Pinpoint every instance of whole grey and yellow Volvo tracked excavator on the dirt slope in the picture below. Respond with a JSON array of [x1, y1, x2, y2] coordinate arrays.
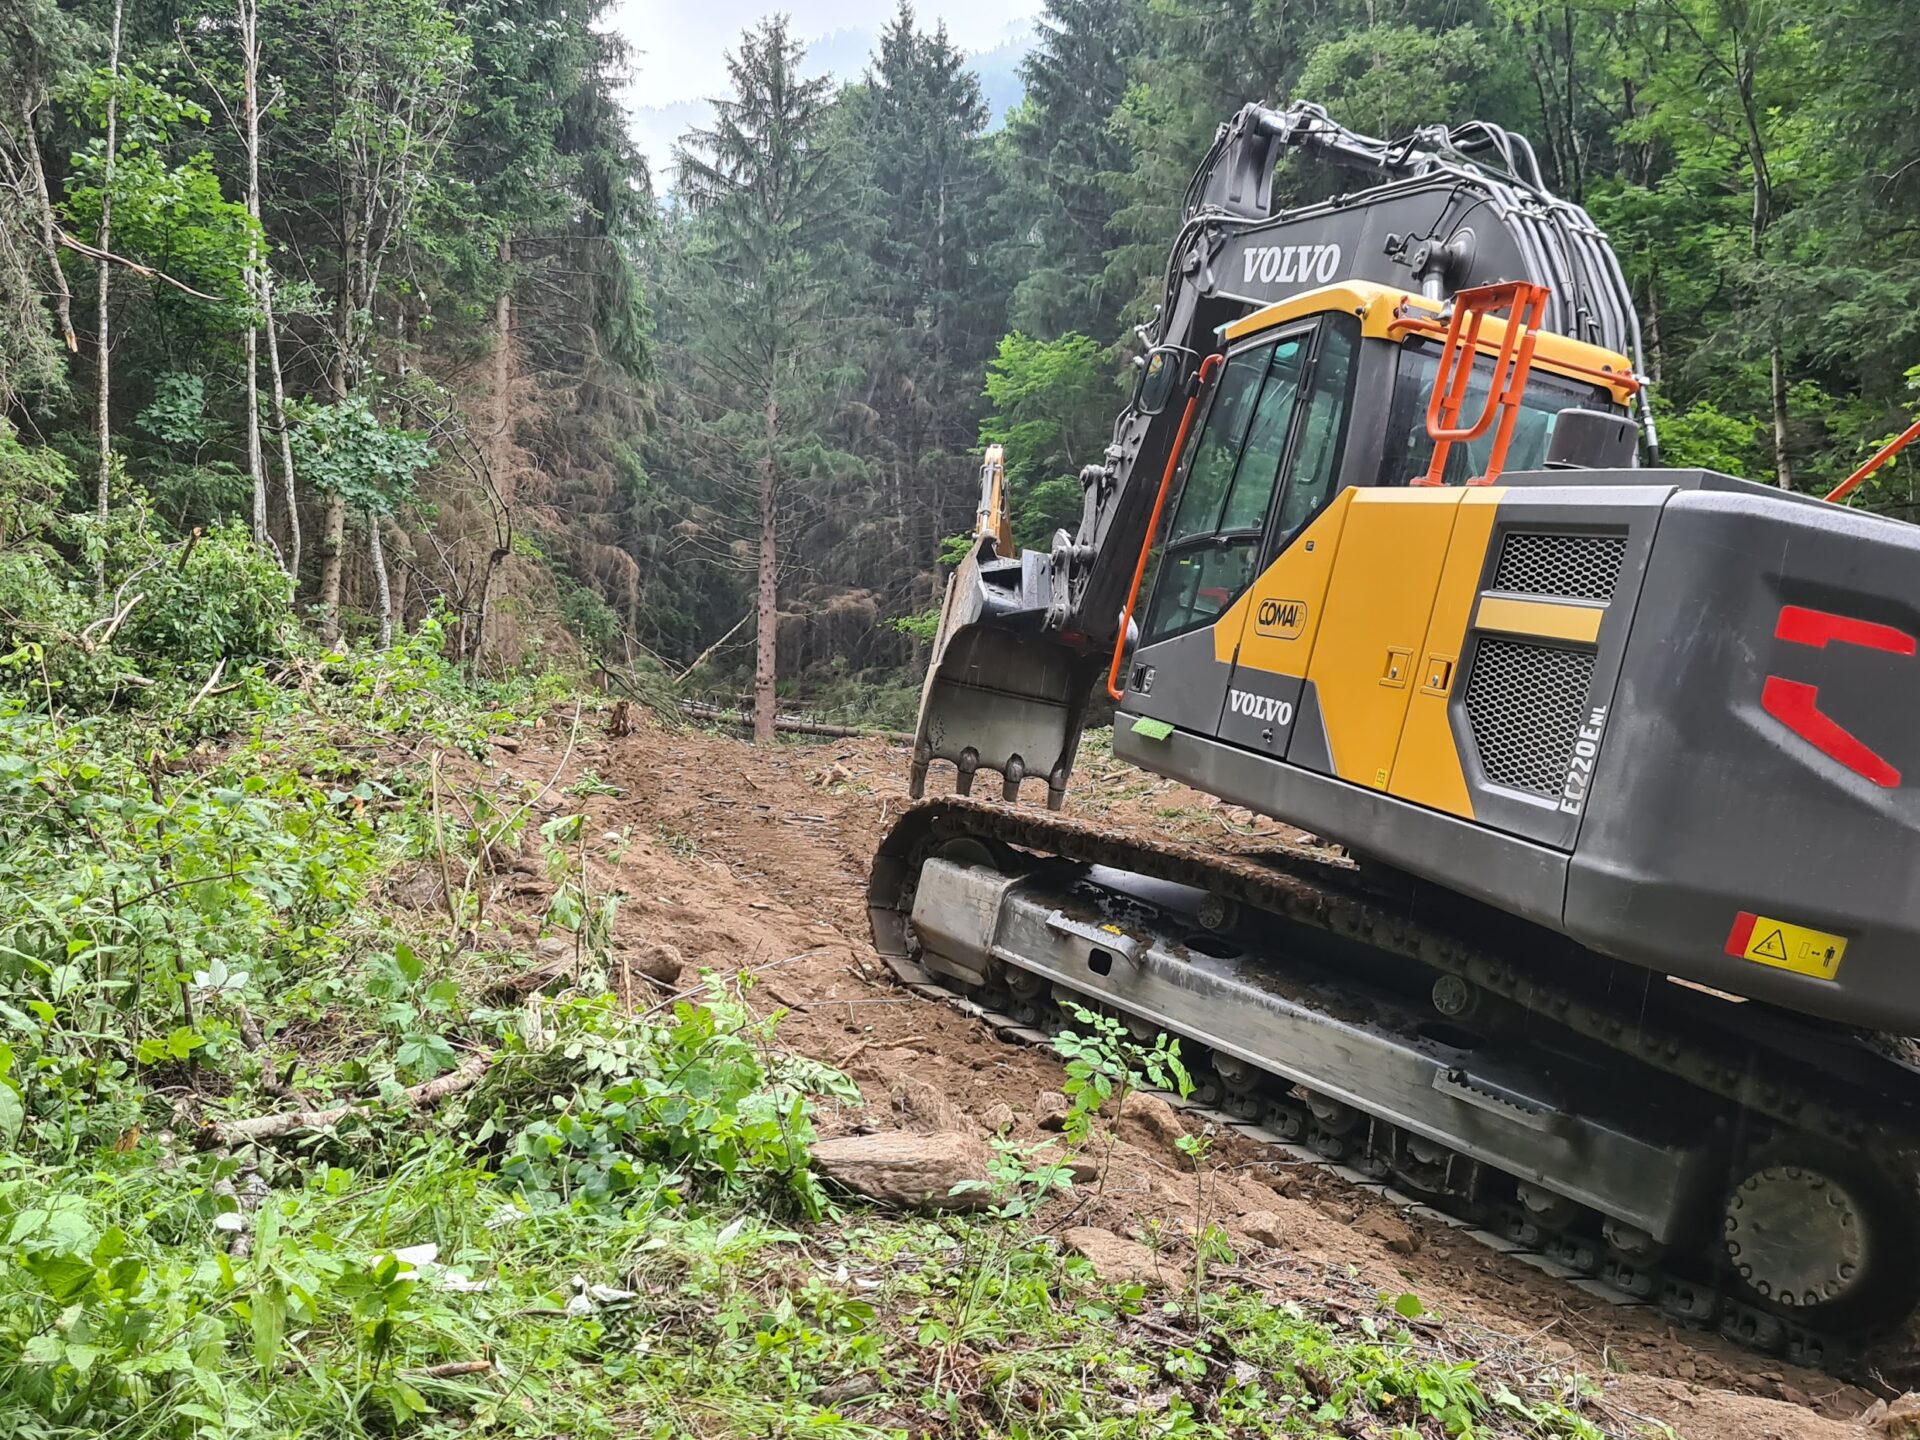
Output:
[[870, 102, 1920, 1365]]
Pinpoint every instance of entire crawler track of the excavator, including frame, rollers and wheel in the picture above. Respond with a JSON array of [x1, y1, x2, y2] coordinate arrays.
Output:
[[868, 797, 1920, 1371]]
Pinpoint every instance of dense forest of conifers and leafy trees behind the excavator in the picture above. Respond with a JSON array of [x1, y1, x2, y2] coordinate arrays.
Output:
[[0, 0, 1920, 708]]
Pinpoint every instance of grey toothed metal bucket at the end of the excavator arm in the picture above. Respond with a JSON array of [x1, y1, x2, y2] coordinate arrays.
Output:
[[908, 445, 1098, 810]]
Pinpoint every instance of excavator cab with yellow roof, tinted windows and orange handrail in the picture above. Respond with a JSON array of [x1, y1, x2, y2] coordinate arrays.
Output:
[[1112, 282, 1634, 749]]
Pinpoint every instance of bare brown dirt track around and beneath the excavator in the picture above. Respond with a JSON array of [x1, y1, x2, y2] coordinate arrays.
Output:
[[465, 710, 1874, 1440]]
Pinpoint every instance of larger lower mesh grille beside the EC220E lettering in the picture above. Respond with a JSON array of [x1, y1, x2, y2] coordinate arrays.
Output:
[[1467, 639, 1594, 795]]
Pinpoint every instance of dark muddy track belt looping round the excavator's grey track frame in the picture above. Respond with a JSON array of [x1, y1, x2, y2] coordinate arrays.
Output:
[[868, 799, 1920, 1371]]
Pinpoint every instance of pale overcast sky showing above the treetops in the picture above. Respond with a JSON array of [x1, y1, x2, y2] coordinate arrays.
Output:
[[611, 0, 1041, 184]]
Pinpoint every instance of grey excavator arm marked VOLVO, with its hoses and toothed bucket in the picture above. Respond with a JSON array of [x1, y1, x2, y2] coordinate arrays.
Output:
[[912, 102, 1657, 808]]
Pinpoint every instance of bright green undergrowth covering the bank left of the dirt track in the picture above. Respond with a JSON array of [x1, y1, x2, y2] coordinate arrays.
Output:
[[0, 488, 1620, 1440]]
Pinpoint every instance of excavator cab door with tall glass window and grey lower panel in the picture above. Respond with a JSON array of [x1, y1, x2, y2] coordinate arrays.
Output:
[[1125, 321, 1319, 735]]
